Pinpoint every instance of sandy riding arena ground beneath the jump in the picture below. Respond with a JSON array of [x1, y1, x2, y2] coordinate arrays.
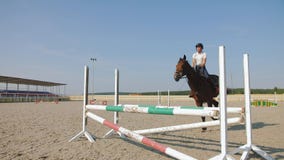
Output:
[[0, 95, 284, 160]]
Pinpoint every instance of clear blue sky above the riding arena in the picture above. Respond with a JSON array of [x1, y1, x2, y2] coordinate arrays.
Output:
[[0, 0, 284, 94]]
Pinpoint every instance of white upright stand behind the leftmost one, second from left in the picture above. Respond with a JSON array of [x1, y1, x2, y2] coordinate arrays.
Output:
[[104, 68, 121, 138]]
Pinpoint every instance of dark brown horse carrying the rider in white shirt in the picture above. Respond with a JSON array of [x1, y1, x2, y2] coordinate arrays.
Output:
[[174, 55, 219, 131]]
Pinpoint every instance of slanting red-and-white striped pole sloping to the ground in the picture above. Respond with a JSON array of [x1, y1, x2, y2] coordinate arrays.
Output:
[[87, 112, 196, 160]]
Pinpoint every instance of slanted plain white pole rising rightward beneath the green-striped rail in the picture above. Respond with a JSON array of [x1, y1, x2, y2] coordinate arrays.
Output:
[[133, 117, 244, 134]]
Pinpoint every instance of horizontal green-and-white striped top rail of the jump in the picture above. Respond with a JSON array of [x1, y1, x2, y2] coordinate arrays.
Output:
[[86, 105, 219, 117]]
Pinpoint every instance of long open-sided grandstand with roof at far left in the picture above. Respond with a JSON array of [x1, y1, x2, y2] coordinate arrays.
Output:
[[0, 76, 66, 102]]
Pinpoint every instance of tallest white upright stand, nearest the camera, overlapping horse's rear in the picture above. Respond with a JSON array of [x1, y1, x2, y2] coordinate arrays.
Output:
[[211, 46, 234, 160]]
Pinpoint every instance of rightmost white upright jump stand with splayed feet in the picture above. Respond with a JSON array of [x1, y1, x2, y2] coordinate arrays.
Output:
[[231, 54, 274, 160]]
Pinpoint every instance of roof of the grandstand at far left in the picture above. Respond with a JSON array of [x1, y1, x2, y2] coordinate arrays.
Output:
[[0, 76, 66, 87]]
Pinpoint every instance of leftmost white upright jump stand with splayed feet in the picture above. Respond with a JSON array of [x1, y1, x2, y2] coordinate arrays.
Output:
[[69, 66, 95, 142]]
